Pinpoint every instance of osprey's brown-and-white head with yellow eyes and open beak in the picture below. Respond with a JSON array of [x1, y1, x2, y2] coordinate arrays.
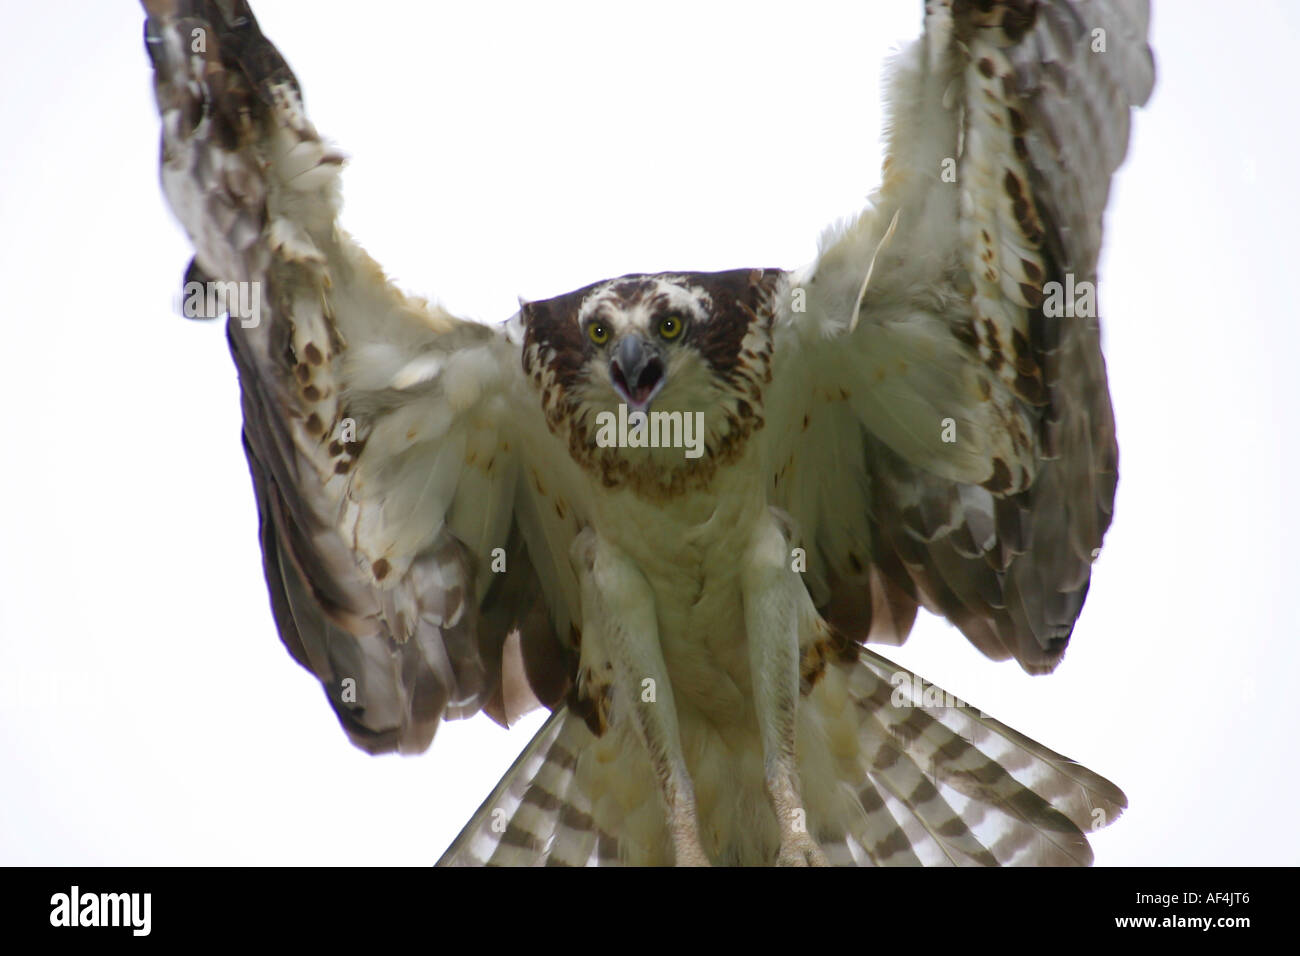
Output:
[[521, 269, 781, 494]]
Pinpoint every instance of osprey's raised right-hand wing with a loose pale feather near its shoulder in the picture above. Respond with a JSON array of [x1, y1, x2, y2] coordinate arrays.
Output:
[[764, 0, 1154, 672]]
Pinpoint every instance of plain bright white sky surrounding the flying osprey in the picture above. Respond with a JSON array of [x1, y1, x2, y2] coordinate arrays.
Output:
[[0, 0, 1300, 865]]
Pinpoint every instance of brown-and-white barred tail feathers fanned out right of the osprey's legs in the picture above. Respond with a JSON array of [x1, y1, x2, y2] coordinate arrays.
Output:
[[827, 650, 1127, 866]]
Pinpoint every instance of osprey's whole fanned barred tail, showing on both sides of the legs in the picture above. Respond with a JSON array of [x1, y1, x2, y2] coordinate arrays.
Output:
[[438, 649, 1127, 866]]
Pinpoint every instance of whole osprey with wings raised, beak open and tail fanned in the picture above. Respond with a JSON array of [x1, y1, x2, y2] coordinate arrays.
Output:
[[144, 0, 1154, 865]]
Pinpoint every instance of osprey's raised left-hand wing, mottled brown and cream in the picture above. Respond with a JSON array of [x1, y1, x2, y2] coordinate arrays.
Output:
[[144, 0, 582, 752]]
